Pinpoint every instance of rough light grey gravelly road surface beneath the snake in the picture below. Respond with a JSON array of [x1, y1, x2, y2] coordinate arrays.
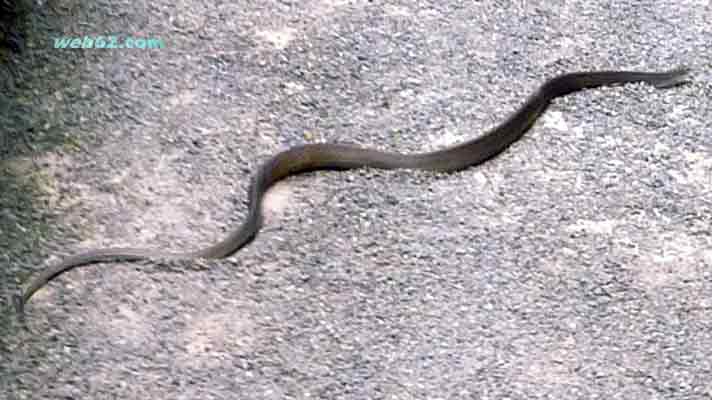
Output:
[[0, 0, 712, 400]]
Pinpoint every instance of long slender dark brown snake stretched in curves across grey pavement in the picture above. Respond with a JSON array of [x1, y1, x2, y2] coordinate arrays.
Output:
[[13, 67, 690, 314]]
